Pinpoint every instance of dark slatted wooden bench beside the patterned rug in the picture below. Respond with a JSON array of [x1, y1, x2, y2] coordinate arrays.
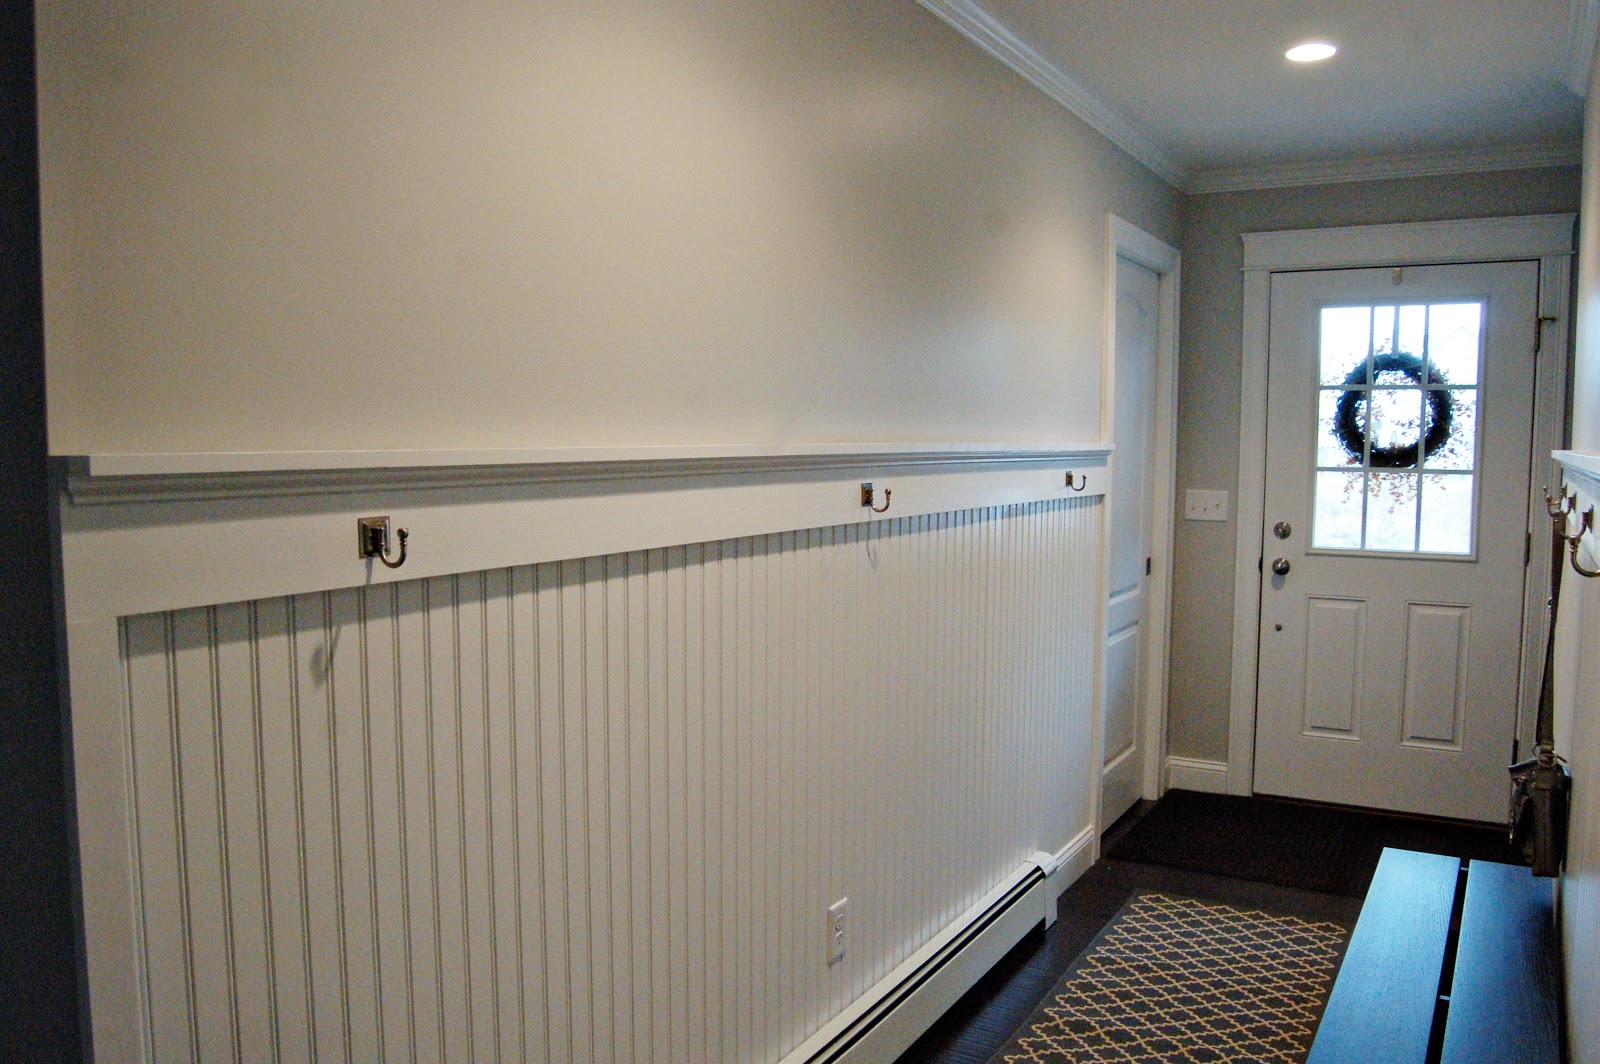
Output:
[[1307, 850, 1562, 1064]]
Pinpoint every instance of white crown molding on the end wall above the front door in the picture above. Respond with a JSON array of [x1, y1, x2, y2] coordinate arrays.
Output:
[[1186, 139, 1580, 194]]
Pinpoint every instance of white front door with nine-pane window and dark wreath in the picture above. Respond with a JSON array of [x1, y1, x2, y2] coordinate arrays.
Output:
[[1254, 262, 1539, 821]]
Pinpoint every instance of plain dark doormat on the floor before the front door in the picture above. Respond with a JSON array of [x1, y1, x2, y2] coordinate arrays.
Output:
[[1106, 790, 1517, 898]]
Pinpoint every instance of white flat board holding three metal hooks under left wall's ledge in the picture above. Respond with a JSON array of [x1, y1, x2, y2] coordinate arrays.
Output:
[[61, 448, 1109, 621]]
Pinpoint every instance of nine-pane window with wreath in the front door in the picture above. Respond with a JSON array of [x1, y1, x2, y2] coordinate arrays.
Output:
[[1312, 302, 1483, 555]]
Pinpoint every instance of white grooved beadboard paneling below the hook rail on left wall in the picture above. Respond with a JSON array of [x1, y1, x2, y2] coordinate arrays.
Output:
[[106, 496, 1102, 1064]]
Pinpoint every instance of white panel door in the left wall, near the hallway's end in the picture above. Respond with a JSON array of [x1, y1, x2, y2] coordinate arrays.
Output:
[[1101, 258, 1160, 827]]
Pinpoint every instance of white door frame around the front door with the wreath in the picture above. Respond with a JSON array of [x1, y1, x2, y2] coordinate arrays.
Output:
[[1227, 214, 1576, 795]]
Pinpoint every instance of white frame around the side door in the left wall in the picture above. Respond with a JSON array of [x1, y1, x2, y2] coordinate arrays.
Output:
[[1093, 214, 1181, 812]]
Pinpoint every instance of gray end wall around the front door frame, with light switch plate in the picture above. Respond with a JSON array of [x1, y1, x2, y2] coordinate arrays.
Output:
[[1168, 166, 1579, 760]]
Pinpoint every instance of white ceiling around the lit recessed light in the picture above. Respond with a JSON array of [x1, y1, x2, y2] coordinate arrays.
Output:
[[923, 0, 1600, 189]]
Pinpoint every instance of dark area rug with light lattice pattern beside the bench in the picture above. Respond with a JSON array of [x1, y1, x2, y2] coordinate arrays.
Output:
[[992, 893, 1347, 1064]]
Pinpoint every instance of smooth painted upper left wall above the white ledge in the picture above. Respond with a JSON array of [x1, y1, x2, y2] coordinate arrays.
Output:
[[37, 0, 1181, 454]]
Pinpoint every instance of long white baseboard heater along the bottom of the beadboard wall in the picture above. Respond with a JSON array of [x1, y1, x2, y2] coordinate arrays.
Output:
[[782, 853, 1059, 1064]]
